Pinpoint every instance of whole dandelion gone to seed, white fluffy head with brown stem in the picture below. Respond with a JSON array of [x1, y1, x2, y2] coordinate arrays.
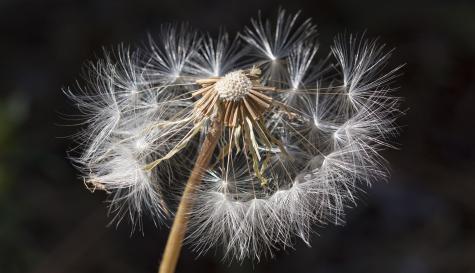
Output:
[[67, 10, 400, 272]]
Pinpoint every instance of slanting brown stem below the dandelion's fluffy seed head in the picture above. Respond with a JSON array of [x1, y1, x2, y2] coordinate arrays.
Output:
[[158, 112, 223, 273]]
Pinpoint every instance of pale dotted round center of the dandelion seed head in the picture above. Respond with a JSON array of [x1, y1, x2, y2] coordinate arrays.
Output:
[[214, 70, 252, 101]]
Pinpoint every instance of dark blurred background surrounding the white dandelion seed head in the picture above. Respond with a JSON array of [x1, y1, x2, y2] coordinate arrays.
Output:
[[0, 0, 475, 273]]
